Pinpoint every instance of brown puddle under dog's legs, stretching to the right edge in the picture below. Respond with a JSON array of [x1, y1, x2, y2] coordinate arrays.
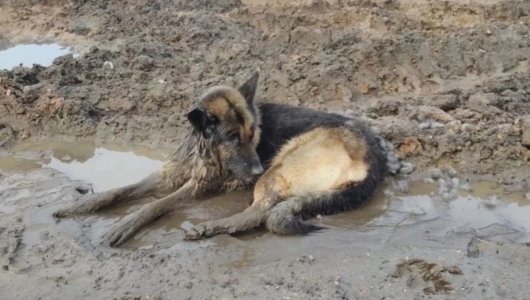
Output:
[[118, 178, 530, 267]]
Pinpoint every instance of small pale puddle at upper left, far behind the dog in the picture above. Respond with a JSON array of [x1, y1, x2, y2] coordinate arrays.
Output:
[[0, 43, 72, 69]]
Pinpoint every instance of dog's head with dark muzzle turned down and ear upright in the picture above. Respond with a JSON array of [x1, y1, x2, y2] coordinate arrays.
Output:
[[188, 72, 263, 180]]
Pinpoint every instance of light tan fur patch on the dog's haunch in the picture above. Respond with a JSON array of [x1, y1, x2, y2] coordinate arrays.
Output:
[[254, 128, 368, 202]]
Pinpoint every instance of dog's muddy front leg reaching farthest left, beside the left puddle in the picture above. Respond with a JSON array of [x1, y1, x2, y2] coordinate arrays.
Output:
[[53, 173, 160, 218]]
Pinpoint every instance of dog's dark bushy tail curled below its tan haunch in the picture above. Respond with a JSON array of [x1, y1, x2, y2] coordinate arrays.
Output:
[[266, 166, 382, 234]]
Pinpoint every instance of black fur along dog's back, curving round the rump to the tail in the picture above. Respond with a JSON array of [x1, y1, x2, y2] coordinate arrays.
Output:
[[257, 103, 387, 233]]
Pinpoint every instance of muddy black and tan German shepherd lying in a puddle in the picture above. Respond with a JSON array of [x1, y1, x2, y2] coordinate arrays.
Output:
[[54, 71, 387, 246]]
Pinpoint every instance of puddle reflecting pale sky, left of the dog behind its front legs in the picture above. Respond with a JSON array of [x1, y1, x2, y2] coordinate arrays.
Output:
[[0, 141, 164, 192]]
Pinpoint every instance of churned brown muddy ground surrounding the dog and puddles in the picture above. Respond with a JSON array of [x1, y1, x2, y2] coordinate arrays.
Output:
[[0, 0, 530, 299]]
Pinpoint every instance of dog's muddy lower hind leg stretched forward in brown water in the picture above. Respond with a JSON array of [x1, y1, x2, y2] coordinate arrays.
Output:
[[185, 203, 270, 240]]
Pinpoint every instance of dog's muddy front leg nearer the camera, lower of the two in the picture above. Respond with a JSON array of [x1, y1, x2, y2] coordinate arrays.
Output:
[[103, 179, 197, 247]]
